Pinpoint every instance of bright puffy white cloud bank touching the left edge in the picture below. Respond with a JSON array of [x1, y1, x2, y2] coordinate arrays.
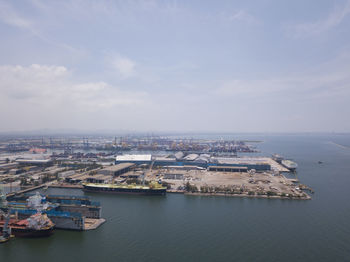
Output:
[[0, 64, 146, 112]]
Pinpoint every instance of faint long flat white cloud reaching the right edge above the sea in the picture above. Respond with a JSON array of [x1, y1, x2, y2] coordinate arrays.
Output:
[[215, 72, 350, 101]]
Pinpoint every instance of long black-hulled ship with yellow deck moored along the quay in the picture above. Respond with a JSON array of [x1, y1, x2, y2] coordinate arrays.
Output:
[[83, 183, 166, 195]]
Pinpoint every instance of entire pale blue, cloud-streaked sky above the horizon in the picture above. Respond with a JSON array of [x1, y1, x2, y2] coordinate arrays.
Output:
[[0, 0, 350, 132]]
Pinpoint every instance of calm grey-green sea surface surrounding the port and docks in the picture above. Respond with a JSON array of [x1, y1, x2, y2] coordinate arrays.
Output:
[[0, 135, 350, 262]]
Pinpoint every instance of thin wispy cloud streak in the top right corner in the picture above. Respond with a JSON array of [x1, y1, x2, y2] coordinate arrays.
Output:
[[287, 0, 350, 38]]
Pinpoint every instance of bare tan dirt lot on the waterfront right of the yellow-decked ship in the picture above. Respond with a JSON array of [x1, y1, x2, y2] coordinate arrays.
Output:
[[146, 169, 306, 197]]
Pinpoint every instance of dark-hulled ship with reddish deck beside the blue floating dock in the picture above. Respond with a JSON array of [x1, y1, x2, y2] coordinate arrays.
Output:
[[0, 213, 55, 237]]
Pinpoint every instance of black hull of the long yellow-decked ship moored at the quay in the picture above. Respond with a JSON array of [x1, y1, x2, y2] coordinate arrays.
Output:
[[83, 185, 166, 196]]
